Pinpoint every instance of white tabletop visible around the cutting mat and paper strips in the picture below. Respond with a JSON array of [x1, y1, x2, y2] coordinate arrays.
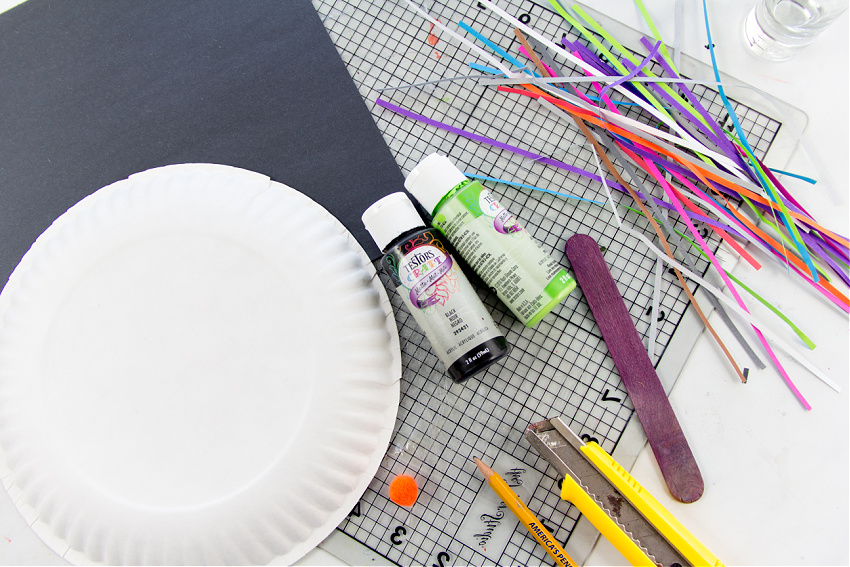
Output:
[[0, 0, 850, 565]]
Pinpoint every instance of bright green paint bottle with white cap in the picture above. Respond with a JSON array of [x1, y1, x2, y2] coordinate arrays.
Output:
[[404, 154, 576, 327]]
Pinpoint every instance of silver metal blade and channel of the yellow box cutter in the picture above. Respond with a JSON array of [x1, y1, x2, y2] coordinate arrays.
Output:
[[525, 418, 690, 567]]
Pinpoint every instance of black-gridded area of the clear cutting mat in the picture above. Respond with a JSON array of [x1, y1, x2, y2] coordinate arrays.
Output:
[[314, 0, 779, 567]]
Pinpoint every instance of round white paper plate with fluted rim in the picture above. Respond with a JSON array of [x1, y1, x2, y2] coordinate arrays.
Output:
[[0, 164, 401, 564]]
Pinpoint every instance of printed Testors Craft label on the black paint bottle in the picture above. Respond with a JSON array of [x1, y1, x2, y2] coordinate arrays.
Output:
[[382, 230, 507, 377]]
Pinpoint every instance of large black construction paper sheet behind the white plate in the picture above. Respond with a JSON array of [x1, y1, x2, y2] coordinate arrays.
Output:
[[0, 0, 404, 284]]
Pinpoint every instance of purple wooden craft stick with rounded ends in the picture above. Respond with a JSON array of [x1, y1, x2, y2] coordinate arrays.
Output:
[[566, 234, 704, 502]]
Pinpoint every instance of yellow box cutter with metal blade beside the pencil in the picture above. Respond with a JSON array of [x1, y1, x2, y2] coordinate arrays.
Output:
[[525, 417, 723, 567]]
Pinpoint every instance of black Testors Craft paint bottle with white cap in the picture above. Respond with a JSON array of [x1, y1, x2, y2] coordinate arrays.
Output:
[[362, 193, 510, 382]]
